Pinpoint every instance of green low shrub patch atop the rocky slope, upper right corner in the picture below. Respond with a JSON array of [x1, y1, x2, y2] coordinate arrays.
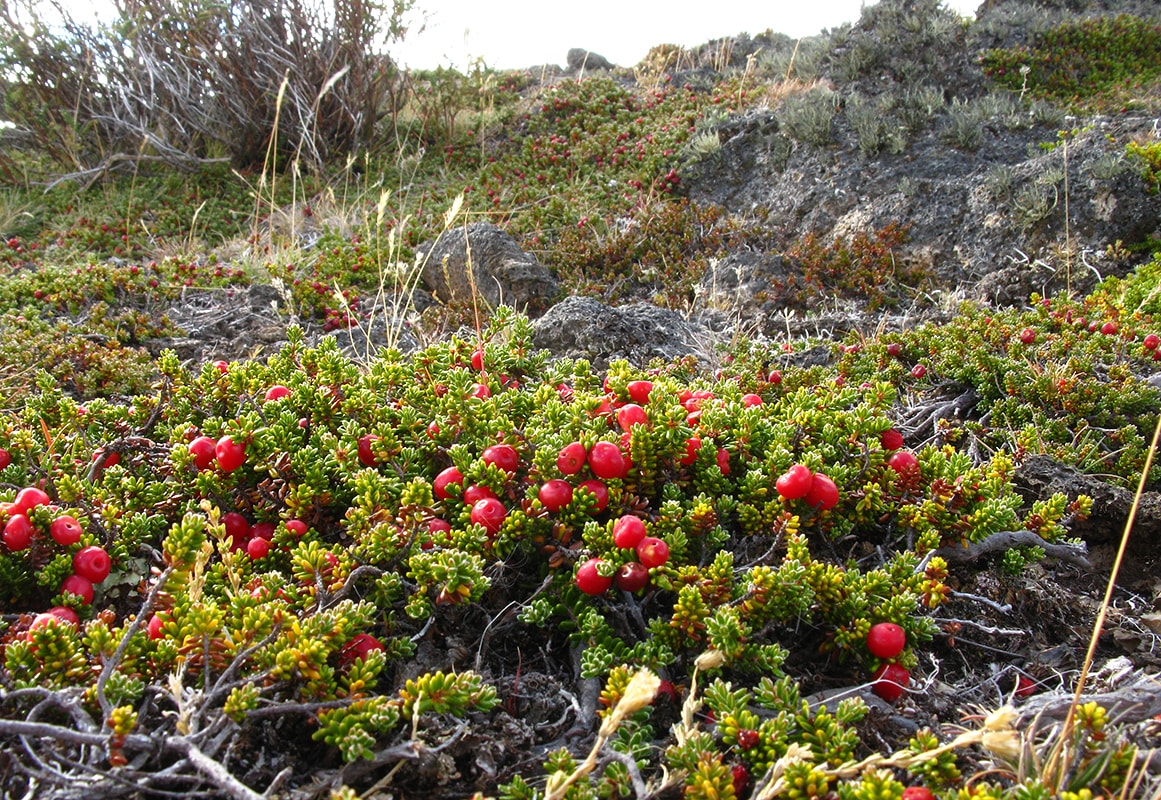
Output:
[[982, 14, 1161, 110]]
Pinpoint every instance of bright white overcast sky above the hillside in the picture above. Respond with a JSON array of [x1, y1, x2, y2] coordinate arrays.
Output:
[[49, 0, 982, 70]]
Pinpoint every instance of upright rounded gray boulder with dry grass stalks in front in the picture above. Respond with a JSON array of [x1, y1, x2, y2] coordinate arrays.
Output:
[[418, 222, 558, 316]]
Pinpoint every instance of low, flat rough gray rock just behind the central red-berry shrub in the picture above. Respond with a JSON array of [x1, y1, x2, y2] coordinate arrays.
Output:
[[533, 297, 712, 369]]
